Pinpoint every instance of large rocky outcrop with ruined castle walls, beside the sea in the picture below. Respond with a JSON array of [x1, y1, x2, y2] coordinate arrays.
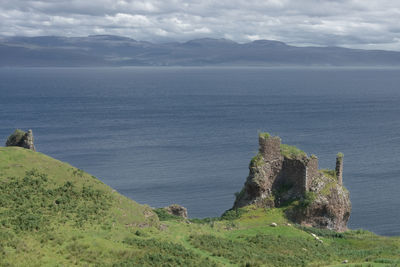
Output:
[[233, 134, 351, 231]]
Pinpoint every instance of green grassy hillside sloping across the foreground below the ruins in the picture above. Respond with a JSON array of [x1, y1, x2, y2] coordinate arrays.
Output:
[[0, 147, 400, 266]]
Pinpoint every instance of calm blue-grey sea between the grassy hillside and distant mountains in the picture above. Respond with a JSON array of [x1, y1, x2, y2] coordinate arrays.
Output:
[[0, 68, 400, 235]]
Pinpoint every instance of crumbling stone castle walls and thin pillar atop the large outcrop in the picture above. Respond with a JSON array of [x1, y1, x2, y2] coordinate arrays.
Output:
[[234, 134, 343, 208]]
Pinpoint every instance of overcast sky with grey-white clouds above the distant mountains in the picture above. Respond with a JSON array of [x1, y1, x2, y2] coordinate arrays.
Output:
[[0, 0, 400, 50]]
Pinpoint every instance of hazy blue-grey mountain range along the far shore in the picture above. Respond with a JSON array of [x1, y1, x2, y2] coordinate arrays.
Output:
[[0, 35, 400, 67]]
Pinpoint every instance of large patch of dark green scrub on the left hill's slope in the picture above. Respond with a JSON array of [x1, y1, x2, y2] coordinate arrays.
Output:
[[0, 169, 111, 231]]
